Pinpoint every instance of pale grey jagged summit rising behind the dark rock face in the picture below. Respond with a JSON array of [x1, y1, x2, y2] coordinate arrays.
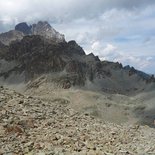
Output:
[[0, 21, 65, 45]]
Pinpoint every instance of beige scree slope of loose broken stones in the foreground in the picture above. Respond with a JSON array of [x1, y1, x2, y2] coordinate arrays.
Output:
[[0, 87, 155, 155]]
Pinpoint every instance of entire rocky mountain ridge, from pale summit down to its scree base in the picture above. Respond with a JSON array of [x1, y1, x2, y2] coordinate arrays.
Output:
[[0, 21, 155, 94]]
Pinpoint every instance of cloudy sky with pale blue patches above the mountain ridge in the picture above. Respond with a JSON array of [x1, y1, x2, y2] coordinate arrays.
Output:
[[0, 0, 155, 74]]
